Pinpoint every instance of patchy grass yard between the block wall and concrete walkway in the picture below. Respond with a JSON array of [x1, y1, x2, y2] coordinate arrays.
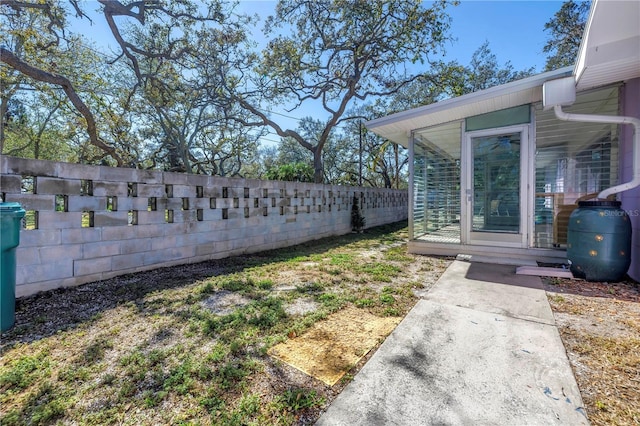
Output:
[[0, 223, 448, 425]]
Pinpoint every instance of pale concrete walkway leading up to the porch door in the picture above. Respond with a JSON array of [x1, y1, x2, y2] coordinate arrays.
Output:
[[316, 261, 589, 426]]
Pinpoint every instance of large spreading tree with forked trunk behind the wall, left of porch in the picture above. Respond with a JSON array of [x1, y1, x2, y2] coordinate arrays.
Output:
[[230, 0, 458, 182]]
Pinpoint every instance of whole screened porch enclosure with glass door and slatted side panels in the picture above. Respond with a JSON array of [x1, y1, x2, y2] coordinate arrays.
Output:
[[410, 86, 619, 250]]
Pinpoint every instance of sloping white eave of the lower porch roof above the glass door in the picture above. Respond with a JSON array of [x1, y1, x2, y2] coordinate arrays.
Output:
[[365, 67, 573, 147]]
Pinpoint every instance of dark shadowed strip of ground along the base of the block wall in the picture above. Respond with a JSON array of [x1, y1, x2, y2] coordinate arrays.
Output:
[[0, 221, 407, 355]]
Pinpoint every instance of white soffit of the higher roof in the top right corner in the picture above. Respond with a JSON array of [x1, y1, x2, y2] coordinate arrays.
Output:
[[574, 0, 640, 90]]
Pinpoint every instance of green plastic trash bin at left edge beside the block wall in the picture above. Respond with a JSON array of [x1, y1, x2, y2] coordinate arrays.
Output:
[[0, 203, 25, 331]]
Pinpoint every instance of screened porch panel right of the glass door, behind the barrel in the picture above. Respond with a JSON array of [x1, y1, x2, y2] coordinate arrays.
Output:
[[533, 86, 620, 248]]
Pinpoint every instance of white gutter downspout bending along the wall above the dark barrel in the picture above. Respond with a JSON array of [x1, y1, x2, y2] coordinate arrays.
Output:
[[553, 105, 640, 199]]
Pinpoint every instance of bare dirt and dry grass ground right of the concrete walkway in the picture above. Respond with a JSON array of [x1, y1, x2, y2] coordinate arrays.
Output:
[[543, 278, 640, 426]]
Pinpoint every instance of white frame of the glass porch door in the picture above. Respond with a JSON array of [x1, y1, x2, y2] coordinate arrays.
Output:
[[460, 124, 533, 248]]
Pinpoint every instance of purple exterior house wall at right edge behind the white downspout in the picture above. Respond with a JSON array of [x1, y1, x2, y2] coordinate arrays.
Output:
[[619, 78, 640, 281]]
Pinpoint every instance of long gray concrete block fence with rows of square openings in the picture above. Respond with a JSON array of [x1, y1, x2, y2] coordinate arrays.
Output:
[[0, 156, 408, 297]]
